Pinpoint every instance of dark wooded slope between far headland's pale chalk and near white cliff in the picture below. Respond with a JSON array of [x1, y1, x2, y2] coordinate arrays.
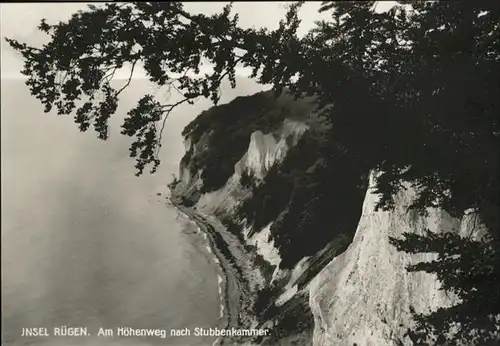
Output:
[[238, 131, 367, 269]]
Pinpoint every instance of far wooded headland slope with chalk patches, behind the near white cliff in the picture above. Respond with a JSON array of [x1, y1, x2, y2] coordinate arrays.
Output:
[[171, 88, 372, 345]]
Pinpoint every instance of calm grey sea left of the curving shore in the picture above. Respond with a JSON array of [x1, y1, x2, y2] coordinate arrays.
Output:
[[2, 81, 219, 346]]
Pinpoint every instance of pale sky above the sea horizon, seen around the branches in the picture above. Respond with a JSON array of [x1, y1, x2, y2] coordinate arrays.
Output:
[[0, 1, 394, 79]]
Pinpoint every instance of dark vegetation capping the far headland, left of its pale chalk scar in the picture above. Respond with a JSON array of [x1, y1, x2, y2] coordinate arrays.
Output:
[[182, 92, 312, 192]]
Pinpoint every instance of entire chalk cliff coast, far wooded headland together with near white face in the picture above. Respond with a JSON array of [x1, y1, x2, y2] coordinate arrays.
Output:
[[172, 93, 496, 346]]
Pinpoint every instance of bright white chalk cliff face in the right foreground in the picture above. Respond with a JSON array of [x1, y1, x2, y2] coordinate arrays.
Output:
[[310, 176, 480, 346]]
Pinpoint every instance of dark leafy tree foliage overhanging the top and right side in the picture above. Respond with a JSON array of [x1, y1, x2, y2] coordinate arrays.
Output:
[[8, 1, 500, 344]]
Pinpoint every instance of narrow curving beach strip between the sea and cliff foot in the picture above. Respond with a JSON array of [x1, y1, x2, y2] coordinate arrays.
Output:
[[170, 195, 250, 346]]
